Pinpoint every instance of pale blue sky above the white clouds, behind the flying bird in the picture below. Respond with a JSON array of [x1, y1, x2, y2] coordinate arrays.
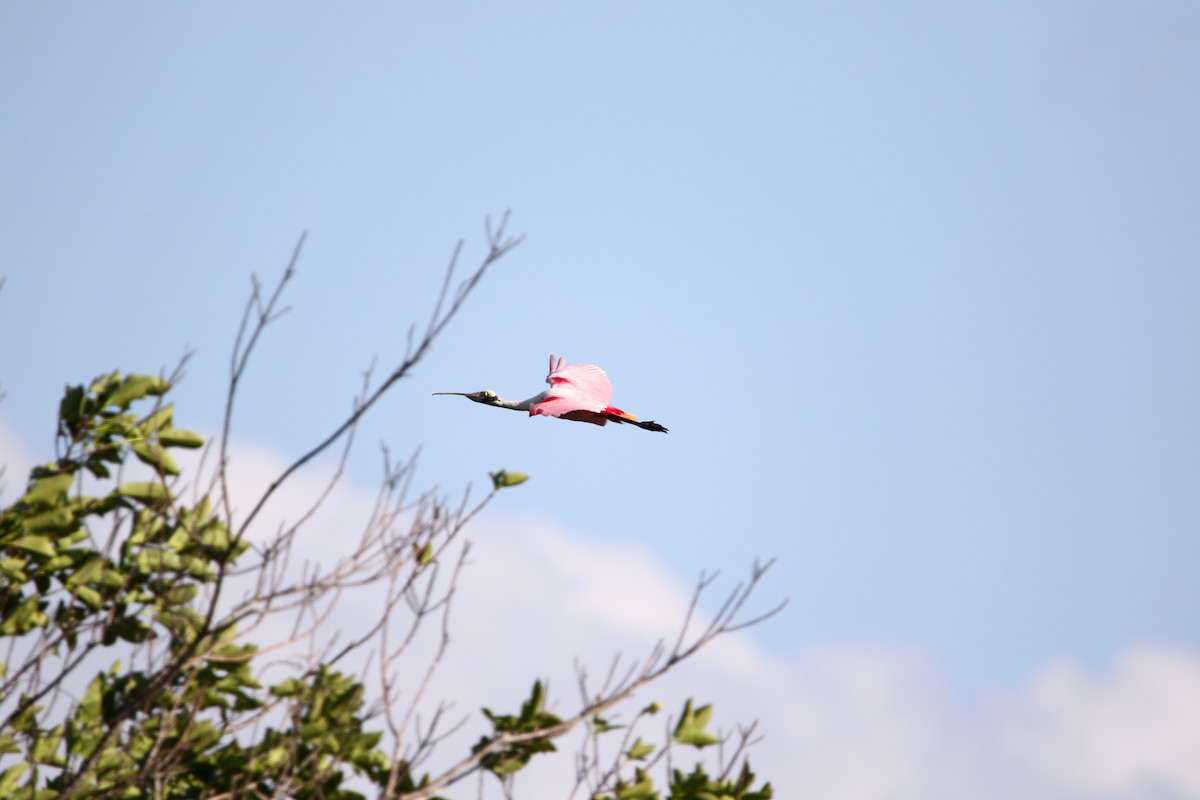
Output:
[[0, 2, 1200, 796]]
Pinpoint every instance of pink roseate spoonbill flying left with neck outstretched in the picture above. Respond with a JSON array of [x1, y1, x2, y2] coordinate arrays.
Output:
[[433, 356, 667, 433]]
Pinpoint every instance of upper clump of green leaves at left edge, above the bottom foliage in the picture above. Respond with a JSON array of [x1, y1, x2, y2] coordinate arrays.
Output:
[[0, 373, 216, 650]]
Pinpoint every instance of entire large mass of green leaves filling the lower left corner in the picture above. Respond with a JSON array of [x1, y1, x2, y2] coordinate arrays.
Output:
[[0, 373, 413, 800]]
